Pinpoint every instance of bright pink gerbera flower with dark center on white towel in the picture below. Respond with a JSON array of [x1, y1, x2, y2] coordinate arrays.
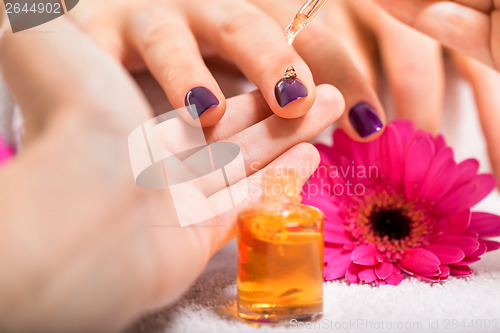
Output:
[[303, 121, 500, 285]]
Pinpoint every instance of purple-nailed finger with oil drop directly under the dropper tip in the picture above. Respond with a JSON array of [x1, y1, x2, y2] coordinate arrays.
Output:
[[185, 0, 315, 118]]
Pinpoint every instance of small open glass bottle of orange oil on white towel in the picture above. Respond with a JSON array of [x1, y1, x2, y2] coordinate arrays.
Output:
[[237, 169, 323, 322]]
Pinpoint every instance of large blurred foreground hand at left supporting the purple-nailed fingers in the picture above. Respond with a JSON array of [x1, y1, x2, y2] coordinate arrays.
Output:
[[0, 17, 344, 332]]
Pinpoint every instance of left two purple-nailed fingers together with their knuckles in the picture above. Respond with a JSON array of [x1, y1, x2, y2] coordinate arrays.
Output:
[[69, 0, 316, 127]]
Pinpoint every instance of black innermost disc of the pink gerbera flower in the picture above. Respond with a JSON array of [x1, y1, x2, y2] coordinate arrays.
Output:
[[370, 209, 411, 239]]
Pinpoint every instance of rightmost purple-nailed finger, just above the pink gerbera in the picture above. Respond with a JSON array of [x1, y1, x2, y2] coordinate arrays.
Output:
[[255, 0, 385, 141]]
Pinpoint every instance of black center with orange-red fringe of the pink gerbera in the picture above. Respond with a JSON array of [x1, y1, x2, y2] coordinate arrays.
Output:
[[345, 187, 436, 261]]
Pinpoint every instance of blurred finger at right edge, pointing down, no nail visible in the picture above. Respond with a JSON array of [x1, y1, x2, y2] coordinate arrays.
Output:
[[452, 53, 500, 185]]
